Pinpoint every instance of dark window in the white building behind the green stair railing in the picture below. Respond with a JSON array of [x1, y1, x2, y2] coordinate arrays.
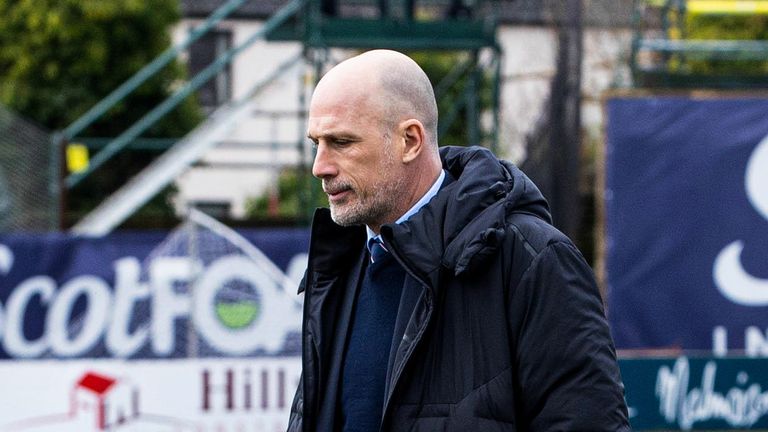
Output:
[[189, 30, 232, 112]]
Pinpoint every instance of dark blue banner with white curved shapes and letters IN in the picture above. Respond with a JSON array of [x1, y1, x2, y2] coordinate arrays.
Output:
[[605, 96, 768, 357]]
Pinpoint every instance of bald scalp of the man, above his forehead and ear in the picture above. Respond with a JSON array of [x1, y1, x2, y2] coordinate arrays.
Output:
[[312, 50, 437, 149]]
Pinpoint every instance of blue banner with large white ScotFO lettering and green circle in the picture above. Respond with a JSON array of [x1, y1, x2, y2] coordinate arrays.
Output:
[[0, 214, 309, 359]]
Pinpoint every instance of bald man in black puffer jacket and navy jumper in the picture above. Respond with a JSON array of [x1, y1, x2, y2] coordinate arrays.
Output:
[[288, 50, 629, 432]]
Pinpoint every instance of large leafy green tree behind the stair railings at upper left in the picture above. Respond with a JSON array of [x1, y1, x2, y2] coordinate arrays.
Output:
[[0, 0, 202, 228]]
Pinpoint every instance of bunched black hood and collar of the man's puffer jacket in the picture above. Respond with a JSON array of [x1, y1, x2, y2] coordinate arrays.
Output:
[[381, 147, 551, 282]]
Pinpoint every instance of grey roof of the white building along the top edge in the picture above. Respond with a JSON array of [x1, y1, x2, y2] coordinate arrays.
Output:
[[180, 0, 633, 27]]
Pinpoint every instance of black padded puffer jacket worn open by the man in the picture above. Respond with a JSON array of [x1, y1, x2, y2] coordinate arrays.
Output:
[[288, 148, 629, 432]]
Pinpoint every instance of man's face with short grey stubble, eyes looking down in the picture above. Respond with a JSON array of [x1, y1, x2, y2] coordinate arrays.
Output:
[[307, 96, 412, 231]]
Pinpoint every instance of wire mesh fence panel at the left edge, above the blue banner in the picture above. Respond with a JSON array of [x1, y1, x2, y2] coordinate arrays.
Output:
[[0, 106, 58, 232]]
